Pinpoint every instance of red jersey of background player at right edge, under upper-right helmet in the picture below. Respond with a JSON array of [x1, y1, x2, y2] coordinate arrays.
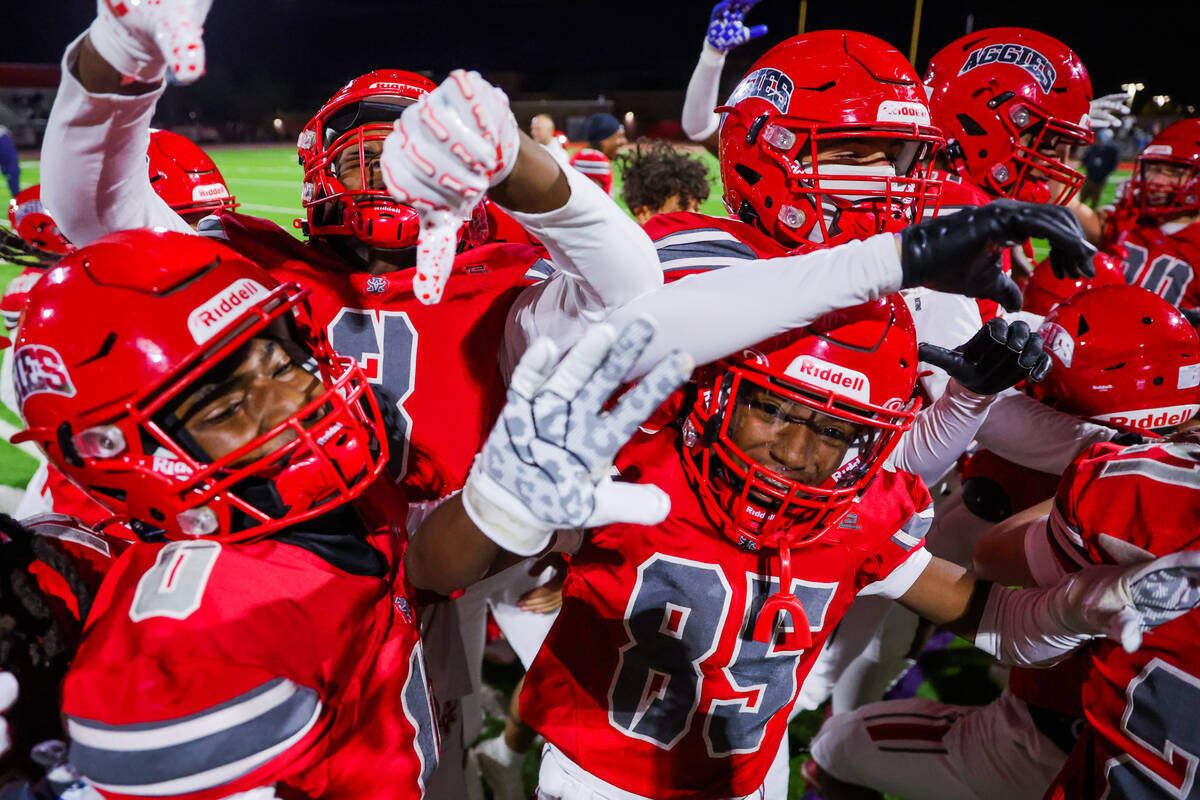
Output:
[[1105, 222, 1200, 308]]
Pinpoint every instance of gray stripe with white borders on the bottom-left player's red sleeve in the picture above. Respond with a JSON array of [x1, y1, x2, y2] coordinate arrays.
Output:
[[67, 679, 320, 795]]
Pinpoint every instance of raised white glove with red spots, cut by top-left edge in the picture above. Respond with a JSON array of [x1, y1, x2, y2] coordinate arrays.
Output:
[[88, 0, 212, 84]]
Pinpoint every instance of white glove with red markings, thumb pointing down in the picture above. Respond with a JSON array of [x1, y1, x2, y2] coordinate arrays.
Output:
[[380, 70, 521, 305]]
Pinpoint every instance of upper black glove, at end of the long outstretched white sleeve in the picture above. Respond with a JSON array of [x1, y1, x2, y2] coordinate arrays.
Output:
[[900, 199, 1096, 311]]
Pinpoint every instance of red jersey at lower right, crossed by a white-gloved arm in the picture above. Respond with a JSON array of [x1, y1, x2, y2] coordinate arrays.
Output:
[[1046, 443, 1200, 800]]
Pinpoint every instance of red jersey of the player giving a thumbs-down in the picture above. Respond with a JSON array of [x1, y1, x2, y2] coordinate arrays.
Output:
[[211, 213, 540, 500]]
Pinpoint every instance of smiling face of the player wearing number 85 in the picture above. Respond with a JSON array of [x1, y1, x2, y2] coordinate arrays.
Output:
[[730, 386, 859, 489]]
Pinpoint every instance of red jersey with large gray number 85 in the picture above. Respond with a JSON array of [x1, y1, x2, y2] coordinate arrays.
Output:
[[521, 431, 932, 800]]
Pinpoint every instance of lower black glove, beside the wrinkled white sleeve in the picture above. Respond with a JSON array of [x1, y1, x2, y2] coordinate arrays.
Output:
[[917, 317, 1050, 395]]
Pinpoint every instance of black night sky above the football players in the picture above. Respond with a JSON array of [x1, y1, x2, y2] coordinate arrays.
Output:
[[0, 0, 1200, 117]]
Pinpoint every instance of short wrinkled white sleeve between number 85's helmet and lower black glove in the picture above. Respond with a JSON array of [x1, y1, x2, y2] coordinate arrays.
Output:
[[889, 380, 995, 486]]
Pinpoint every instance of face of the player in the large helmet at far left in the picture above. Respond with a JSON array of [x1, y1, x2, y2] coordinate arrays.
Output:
[[175, 337, 324, 467]]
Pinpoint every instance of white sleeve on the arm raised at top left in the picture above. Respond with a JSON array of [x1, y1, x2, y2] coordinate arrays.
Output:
[[41, 36, 192, 247]]
